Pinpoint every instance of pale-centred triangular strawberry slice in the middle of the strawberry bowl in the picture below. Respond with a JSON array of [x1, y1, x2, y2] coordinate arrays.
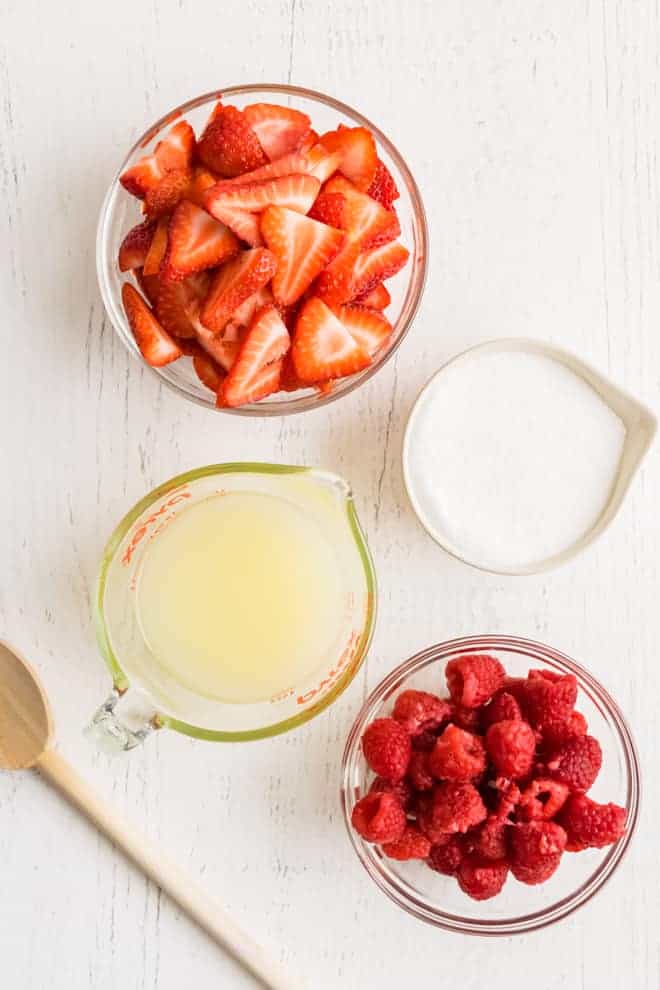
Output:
[[261, 206, 344, 306]]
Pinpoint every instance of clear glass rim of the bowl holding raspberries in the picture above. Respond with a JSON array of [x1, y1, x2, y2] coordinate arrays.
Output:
[[340, 635, 640, 936]]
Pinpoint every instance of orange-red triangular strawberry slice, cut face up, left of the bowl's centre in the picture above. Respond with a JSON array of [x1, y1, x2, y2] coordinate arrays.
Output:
[[163, 200, 240, 279]]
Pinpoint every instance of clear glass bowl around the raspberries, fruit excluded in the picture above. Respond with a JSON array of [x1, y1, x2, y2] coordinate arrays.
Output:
[[341, 636, 640, 935]]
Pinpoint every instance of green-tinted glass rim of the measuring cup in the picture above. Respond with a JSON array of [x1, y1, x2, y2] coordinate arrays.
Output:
[[93, 461, 378, 742]]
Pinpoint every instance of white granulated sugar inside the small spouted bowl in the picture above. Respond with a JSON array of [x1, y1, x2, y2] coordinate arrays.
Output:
[[406, 349, 626, 571]]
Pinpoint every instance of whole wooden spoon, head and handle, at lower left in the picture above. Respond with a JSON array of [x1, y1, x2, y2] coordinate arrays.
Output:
[[0, 640, 300, 990]]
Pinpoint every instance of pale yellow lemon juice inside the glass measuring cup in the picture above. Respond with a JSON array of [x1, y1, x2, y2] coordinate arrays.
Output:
[[135, 492, 347, 703]]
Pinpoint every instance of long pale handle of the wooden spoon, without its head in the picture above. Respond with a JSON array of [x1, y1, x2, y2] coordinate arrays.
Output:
[[37, 749, 300, 990]]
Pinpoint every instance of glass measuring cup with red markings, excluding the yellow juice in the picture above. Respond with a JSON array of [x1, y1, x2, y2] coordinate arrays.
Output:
[[87, 463, 376, 752]]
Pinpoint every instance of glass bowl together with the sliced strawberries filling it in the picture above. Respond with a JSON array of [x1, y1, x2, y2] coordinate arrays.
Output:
[[97, 85, 428, 416]]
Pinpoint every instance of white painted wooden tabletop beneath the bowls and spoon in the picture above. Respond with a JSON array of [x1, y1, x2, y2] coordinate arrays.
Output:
[[0, 0, 660, 990]]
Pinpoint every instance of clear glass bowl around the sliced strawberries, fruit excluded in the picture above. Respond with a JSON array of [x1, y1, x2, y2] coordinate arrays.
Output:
[[96, 84, 428, 416]]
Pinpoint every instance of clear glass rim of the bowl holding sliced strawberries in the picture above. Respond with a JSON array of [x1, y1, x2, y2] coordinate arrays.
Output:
[[96, 83, 429, 416]]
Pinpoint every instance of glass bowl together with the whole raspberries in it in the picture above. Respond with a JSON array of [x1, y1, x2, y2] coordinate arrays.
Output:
[[342, 636, 640, 935]]
